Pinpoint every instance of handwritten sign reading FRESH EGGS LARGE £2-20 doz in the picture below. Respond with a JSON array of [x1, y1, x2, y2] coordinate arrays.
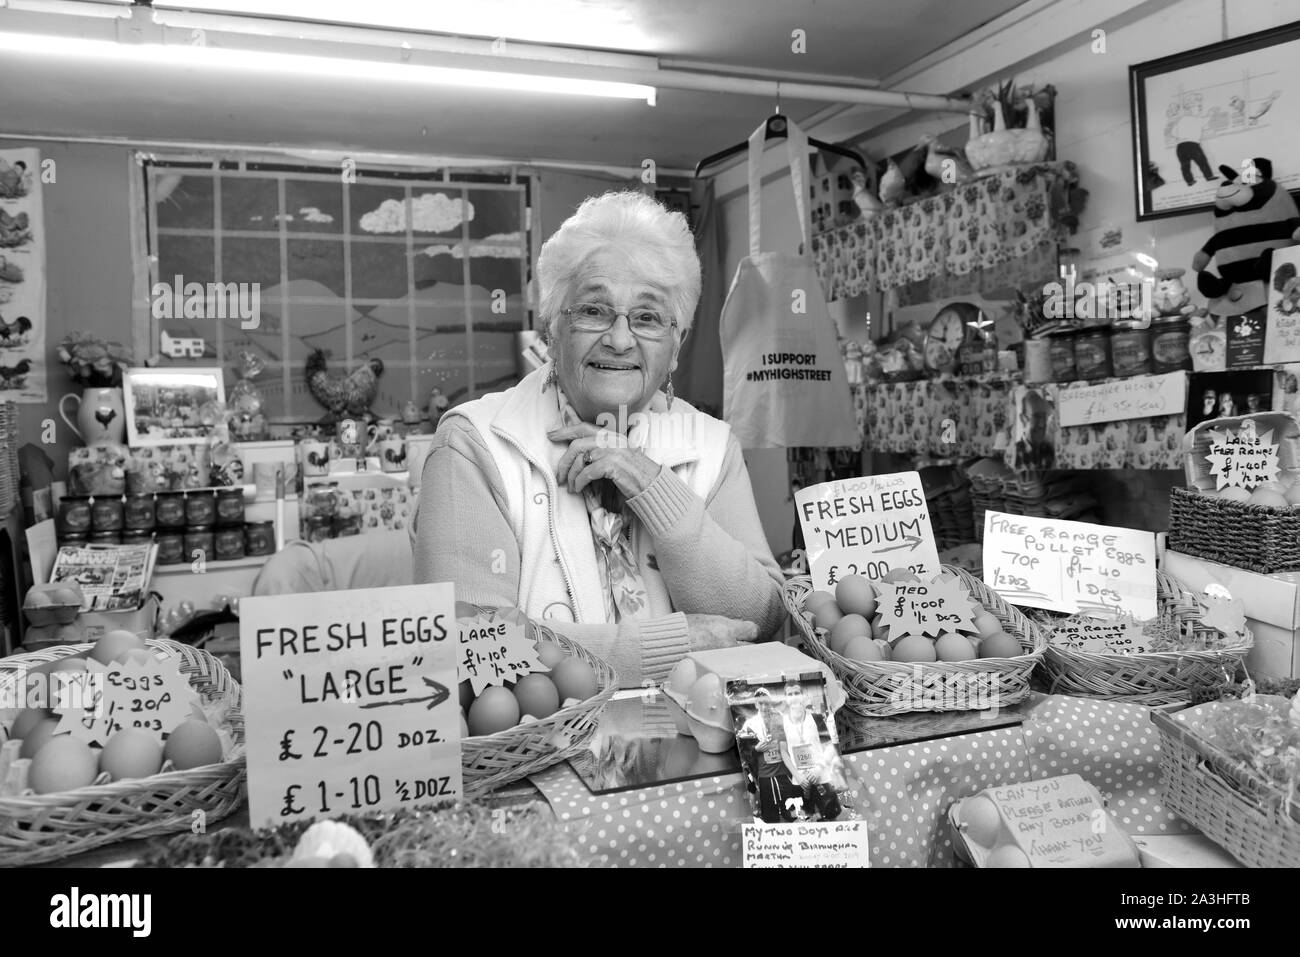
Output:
[[239, 584, 460, 827]]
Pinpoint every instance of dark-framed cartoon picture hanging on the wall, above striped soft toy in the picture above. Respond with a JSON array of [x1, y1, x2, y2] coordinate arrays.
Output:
[[1128, 22, 1300, 220]]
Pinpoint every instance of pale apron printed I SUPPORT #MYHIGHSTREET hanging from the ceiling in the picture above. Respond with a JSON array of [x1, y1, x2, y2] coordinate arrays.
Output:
[[720, 115, 862, 449]]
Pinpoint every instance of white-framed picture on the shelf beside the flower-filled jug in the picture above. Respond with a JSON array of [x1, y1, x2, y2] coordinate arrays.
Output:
[[122, 368, 226, 449]]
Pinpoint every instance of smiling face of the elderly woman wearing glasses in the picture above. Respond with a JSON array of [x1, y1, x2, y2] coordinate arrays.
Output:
[[551, 248, 681, 423]]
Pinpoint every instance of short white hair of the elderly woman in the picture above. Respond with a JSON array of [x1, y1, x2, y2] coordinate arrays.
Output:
[[537, 190, 699, 337]]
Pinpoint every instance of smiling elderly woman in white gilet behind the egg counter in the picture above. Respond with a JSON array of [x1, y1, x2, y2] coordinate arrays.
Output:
[[412, 192, 784, 687]]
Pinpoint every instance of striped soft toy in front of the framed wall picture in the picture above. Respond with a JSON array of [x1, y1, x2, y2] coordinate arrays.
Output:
[[1192, 157, 1300, 316]]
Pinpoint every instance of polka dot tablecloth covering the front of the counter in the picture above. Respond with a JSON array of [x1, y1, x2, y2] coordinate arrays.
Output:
[[532, 696, 1192, 867]]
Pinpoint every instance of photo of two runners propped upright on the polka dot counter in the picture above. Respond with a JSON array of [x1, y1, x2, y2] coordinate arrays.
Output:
[[727, 672, 857, 824]]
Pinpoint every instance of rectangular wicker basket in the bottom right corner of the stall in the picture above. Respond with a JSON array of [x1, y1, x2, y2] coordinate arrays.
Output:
[[1151, 711, 1300, 867]]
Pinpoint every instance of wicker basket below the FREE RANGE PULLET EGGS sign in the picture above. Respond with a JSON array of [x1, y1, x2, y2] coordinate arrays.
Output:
[[1043, 572, 1253, 707]]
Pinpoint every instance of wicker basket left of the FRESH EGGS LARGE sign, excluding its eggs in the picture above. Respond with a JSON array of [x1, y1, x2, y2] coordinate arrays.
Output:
[[0, 638, 244, 866]]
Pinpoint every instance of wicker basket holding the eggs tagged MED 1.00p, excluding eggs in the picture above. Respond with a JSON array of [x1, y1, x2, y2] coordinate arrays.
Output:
[[784, 564, 1047, 718]]
